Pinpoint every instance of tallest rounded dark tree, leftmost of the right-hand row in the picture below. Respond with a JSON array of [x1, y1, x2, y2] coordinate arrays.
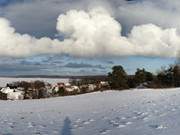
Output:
[[108, 66, 128, 90]]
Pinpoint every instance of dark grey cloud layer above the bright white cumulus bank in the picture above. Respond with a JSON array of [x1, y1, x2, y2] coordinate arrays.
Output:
[[0, 0, 180, 37]]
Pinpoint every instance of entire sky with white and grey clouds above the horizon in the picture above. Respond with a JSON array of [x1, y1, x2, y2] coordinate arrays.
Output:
[[0, 0, 180, 76]]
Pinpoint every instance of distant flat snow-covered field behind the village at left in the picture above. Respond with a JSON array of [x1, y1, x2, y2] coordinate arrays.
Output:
[[0, 77, 69, 87]]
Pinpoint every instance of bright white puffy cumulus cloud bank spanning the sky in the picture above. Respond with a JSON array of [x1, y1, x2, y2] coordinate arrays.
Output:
[[0, 7, 180, 57]]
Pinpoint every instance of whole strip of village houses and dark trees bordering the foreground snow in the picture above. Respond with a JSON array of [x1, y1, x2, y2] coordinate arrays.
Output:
[[0, 64, 180, 100]]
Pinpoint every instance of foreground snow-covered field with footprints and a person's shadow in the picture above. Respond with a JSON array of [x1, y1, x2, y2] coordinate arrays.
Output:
[[0, 88, 180, 135]]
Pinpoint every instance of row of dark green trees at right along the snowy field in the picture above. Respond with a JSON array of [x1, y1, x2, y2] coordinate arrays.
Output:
[[108, 64, 180, 90]]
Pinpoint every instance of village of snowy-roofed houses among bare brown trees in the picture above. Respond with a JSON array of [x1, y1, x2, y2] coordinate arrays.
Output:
[[0, 80, 110, 100]]
